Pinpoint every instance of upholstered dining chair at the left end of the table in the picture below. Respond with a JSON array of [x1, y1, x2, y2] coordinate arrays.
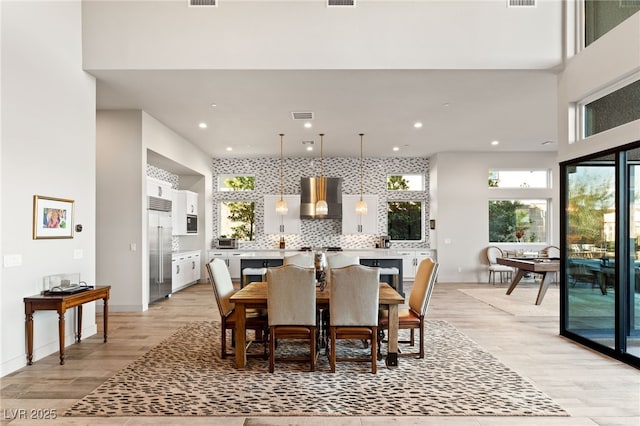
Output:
[[206, 259, 268, 359]]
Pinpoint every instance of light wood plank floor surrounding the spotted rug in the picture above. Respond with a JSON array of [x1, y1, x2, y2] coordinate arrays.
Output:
[[0, 283, 640, 426]]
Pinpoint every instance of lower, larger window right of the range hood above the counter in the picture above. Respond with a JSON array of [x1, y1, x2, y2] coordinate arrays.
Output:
[[387, 201, 424, 241]]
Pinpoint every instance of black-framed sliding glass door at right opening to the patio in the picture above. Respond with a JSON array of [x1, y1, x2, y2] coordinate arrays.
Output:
[[560, 146, 640, 366]]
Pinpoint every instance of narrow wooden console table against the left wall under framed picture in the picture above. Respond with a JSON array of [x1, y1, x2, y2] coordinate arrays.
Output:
[[24, 285, 111, 365]]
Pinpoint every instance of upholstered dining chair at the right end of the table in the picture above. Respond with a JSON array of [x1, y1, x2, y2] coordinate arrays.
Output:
[[378, 259, 440, 359]]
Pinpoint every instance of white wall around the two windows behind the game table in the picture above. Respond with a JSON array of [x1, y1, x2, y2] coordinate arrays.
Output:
[[430, 152, 559, 283]]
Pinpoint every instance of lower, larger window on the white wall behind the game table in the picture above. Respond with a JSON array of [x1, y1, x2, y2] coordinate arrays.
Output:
[[489, 199, 549, 243]]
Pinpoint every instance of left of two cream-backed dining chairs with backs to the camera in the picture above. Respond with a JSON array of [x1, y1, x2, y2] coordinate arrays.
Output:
[[267, 265, 317, 373]]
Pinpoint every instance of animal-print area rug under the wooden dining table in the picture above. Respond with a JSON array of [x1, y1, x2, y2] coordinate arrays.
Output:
[[65, 321, 567, 416]]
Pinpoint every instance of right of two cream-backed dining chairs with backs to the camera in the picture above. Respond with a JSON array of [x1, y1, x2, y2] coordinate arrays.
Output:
[[329, 265, 380, 374]]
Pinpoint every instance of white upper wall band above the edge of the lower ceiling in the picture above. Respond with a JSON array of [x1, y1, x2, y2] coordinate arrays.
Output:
[[83, 0, 563, 70]]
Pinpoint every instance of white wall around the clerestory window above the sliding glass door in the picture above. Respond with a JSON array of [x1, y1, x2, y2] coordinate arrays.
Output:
[[558, 13, 640, 162]]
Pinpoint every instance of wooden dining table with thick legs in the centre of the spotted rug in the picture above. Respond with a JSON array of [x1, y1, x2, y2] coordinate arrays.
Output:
[[229, 282, 405, 369]]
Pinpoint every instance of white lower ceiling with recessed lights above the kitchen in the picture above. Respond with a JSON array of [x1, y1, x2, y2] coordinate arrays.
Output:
[[92, 70, 557, 157]]
